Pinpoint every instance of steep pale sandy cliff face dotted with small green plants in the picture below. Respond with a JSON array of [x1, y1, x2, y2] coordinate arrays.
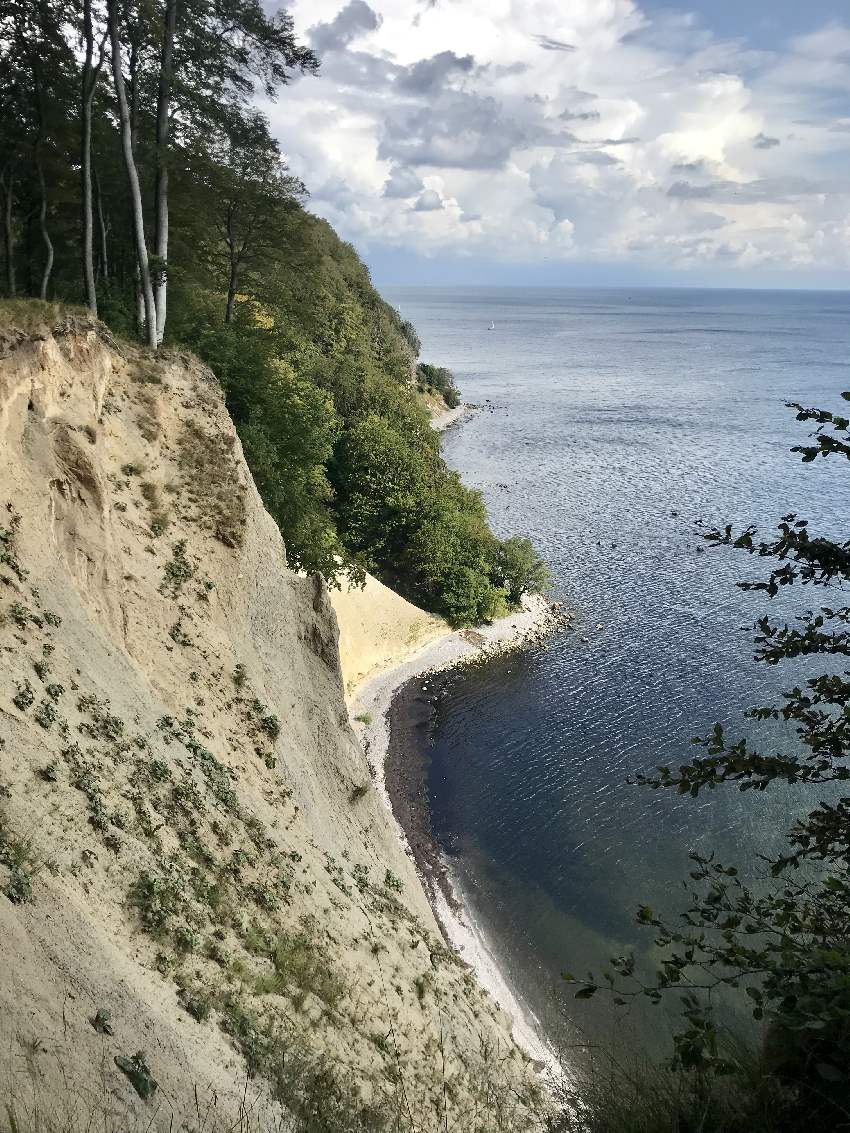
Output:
[[0, 317, 546, 1131]]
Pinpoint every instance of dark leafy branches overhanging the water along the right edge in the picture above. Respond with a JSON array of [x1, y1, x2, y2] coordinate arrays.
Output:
[[570, 393, 850, 1131]]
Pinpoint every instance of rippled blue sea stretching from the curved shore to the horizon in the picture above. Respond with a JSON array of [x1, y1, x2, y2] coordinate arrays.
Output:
[[388, 288, 850, 1043]]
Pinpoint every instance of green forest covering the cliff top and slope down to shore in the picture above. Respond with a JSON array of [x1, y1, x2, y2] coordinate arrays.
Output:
[[0, 0, 546, 625]]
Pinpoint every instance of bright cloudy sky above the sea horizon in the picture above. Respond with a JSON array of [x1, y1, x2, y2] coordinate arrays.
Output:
[[269, 0, 850, 288]]
